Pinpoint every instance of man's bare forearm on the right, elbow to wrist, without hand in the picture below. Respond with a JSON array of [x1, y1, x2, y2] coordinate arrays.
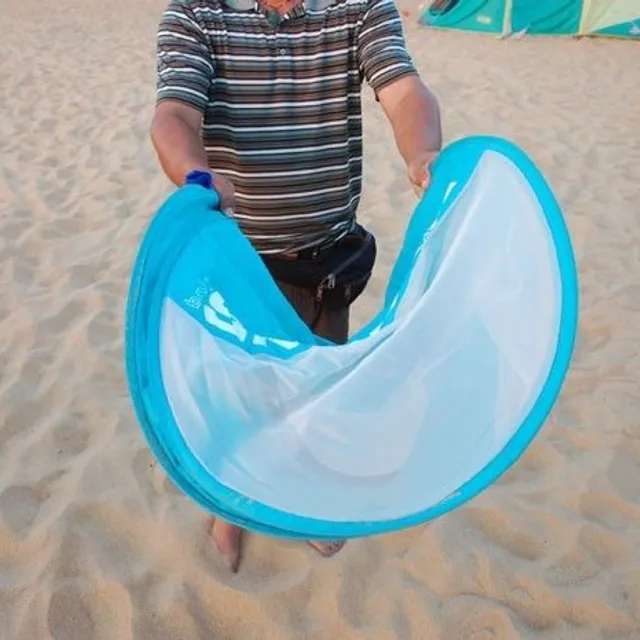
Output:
[[390, 82, 442, 164]]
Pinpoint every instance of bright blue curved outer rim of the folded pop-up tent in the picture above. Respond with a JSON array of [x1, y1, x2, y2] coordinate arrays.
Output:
[[125, 135, 579, 539]]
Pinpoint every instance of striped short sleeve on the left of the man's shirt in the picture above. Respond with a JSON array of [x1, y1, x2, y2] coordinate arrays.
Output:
[[156, 0, 214, 111]]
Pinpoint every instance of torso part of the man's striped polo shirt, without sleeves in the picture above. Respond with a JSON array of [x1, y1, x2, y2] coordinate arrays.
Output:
[[194, 0, 366, 253]]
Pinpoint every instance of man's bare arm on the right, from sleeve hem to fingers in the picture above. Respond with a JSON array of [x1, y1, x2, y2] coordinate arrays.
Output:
[[378, 75, 442, 195]]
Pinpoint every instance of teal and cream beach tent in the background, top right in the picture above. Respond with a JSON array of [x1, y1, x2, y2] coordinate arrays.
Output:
[[420, 0, 640, 39]]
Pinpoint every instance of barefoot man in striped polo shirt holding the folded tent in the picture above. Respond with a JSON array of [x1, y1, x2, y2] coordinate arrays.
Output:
[[151, 0, 442, 571]]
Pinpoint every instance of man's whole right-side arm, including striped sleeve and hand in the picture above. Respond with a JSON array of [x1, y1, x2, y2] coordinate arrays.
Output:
[[358, 0, 442, 188]]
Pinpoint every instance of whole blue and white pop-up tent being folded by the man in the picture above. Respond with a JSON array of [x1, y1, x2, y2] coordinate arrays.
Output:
[[126, 137, 578, 538]]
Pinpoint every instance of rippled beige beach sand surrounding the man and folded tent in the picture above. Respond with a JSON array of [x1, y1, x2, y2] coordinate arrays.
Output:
[[0, 0, 640, 640]]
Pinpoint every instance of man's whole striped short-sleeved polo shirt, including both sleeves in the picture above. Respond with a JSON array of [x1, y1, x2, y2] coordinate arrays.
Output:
[[157, 0, 416, 254]]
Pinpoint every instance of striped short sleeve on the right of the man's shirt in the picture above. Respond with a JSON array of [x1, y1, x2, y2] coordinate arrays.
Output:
[[357, 0, 417, 94]]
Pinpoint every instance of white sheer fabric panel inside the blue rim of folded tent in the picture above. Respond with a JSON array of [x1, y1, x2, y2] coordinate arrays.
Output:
[[161, 152, 560, 521]]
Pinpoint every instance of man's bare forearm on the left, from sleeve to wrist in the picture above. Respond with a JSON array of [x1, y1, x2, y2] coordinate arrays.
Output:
[[151, 113, 207, 186]]
